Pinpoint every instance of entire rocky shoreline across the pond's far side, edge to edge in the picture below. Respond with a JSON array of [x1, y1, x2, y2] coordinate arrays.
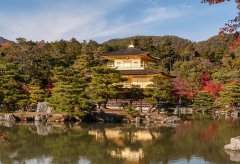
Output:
[[0, 102, 239, 127]]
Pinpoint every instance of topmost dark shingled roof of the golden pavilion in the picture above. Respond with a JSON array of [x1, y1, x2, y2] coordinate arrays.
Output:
[[103, 47, 146, 56]]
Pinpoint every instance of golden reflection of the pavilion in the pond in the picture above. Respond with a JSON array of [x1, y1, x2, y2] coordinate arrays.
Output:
[[88, 128, 161, 162]]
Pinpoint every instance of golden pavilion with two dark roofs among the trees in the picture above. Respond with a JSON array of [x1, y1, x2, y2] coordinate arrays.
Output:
[[103, 45, 172, 88]]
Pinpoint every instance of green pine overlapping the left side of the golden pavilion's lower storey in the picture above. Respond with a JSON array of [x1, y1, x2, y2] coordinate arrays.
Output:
[[87, 66, 126, 108]]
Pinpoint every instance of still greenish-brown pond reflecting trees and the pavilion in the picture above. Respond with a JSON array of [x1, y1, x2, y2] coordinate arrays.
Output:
[[0, 118, 240, 164]]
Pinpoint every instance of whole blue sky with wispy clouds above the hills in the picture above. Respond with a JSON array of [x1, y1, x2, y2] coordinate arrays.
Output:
[[0, 0, 238, 42]]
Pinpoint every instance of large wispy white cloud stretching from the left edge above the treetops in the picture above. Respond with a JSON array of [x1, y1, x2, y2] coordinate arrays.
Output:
[[0, 0, 182, 41]]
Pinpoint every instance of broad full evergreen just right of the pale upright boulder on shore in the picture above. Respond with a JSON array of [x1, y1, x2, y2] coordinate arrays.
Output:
[[47, 67, 94, 115]]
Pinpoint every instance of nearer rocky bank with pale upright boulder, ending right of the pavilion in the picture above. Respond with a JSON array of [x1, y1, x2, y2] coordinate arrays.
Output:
[[0, 102, 186, 126]]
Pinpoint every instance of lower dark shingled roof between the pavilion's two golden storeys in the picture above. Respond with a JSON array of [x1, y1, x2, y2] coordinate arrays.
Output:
[[120, 70, 175, 78]]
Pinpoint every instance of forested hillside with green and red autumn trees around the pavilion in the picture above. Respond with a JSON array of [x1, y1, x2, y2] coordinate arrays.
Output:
[[0, 35, 240, 113]]
